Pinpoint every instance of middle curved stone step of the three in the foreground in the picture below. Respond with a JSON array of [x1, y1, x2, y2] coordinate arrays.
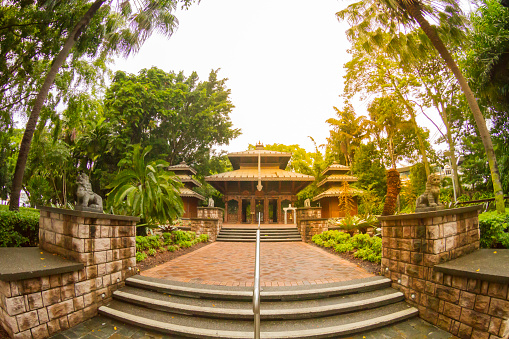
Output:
[[113, 287, 404, 320]]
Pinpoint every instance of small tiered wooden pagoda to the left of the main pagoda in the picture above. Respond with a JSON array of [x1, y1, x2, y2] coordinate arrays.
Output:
[[168, 161, 205, 218]]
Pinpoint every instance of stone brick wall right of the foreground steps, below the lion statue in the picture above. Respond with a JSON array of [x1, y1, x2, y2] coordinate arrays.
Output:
[[380, 206, 509, 339]]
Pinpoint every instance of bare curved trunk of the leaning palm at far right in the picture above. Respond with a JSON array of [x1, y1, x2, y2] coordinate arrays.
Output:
[[403, 0, 505, 213]]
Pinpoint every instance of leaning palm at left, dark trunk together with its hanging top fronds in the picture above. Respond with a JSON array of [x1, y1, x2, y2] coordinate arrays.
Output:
[[9, 0, 192, 211]]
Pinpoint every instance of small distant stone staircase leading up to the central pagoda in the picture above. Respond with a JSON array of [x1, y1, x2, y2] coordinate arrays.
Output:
[[216, 227, 302, 242]]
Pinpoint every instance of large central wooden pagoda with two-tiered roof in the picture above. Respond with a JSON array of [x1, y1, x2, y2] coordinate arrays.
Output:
[[205, 144, 315, 224]]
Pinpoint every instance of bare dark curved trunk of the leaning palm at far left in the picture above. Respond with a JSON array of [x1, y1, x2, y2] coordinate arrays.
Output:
[[9, 0, 106, 211]]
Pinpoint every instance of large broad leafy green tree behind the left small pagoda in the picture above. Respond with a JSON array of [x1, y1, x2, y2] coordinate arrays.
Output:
[[104, 68, 240, 169]]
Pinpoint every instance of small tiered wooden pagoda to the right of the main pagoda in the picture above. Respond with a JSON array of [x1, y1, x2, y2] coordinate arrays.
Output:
[[313, 163, 361, 218]]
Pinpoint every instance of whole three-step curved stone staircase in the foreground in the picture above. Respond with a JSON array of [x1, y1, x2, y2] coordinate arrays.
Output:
[[99, 276, 418, 339]]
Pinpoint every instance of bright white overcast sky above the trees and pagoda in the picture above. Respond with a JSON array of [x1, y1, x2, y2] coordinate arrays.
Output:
[[112, 0, 444, 156]]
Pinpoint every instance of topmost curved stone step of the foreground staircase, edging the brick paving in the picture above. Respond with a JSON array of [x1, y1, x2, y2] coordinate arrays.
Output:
[[126, 275, 391, 301]]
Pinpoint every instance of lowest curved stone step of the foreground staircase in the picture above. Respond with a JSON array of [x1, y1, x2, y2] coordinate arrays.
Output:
[[99, 300, 418, 339]]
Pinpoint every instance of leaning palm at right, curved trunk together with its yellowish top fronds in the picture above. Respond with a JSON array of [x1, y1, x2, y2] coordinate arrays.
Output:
[[336, 0, 505, 213]]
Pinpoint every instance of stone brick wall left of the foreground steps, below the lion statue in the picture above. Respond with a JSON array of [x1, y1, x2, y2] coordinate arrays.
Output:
[[0, 208, 139, 338]]
